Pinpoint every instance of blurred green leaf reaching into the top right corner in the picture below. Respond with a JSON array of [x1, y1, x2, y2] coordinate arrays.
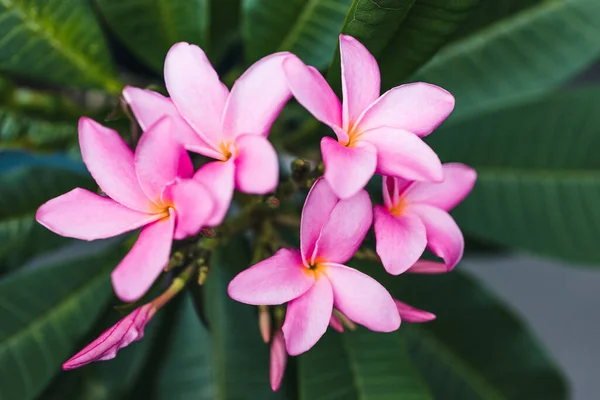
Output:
[[412, 0, 600, 119]]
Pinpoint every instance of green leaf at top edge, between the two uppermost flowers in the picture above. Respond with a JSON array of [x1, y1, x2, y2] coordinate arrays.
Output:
[[242, 0, 352, 68]]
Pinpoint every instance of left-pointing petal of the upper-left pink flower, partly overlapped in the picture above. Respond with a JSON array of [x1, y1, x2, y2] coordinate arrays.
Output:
[[123, 86, 220, 158]]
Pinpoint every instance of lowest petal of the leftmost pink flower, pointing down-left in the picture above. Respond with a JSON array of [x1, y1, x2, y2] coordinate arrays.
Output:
[[112, 216, 175, 303]]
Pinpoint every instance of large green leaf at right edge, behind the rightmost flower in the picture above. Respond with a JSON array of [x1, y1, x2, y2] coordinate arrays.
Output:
[[429, 88, 600, 264]]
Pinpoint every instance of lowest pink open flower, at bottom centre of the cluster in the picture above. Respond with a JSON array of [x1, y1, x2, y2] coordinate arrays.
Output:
[[228, 179, 400, 355]]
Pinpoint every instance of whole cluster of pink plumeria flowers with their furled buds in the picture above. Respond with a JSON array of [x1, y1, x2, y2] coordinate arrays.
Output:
[[37, 35, 476, 390]]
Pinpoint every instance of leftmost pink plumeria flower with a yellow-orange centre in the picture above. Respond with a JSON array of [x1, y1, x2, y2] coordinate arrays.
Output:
[[36, 118, 214, 302]]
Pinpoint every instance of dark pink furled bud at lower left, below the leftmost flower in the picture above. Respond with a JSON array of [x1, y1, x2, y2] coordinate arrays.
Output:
[[63, 304, 156, 370]]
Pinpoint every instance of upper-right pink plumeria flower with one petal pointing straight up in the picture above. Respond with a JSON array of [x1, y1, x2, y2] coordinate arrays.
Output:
[[284, 35, 454, 198]]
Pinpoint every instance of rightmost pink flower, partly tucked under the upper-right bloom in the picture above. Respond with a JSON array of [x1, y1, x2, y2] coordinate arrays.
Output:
[[374, 164, 477, 275]]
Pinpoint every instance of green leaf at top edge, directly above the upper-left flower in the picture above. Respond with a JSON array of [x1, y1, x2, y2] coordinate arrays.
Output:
[[96, 0, 210, 74]]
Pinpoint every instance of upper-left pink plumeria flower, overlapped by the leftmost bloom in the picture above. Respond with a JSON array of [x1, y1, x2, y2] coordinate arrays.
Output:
[[123, 42, 291, 225]]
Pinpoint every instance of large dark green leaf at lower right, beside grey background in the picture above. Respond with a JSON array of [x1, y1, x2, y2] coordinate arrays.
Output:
[[351, 261, 567, 400]]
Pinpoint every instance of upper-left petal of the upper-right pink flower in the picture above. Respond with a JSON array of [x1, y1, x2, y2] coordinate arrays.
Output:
[[283, 55, 342, 128]]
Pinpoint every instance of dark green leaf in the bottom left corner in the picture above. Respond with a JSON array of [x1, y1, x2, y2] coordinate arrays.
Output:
[[0, 248, 121, 400]]
